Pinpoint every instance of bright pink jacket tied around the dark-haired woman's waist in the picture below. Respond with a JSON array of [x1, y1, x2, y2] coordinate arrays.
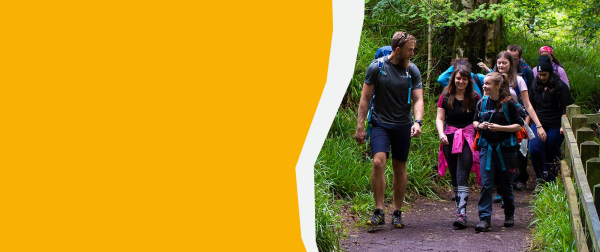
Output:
[[438, 124, 481, 185]]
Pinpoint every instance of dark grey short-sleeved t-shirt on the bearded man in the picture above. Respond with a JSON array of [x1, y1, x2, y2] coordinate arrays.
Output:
[[365, 56, 423, 125]]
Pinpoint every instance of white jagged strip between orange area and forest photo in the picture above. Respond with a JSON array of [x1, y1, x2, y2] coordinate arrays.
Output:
[[296, 0, 365, 251]]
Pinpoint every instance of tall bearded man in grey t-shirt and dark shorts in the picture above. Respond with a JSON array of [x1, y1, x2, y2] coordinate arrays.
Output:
[[355, 31, 423, 228]]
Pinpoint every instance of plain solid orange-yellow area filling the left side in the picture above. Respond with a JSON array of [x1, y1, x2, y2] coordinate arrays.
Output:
[[0, 1, 332, 251]]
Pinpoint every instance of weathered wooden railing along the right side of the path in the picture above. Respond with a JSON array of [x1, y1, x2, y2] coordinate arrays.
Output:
[[561, 105, 600, 252]]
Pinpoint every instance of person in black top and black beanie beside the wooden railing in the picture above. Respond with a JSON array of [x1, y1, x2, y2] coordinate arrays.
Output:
[[529, 55, 571, 185]]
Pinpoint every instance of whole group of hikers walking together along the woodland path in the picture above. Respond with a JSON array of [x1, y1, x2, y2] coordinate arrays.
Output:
[[355, 31, 571, 232]]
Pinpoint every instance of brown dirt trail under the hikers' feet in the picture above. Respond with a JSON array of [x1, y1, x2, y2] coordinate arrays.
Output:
[[340, 188, 533, 251]]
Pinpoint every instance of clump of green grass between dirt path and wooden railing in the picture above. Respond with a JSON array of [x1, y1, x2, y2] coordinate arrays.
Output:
[[531, 180, 577, 251]]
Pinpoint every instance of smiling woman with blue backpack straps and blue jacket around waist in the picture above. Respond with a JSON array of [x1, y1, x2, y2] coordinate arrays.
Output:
[[473, 72, 523, 232]]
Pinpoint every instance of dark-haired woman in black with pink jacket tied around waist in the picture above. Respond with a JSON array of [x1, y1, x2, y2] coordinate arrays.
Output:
[[435, 66, 480, 229]]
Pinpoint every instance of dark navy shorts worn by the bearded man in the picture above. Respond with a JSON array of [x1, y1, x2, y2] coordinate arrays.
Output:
[[371, 122, 412, 162]]
